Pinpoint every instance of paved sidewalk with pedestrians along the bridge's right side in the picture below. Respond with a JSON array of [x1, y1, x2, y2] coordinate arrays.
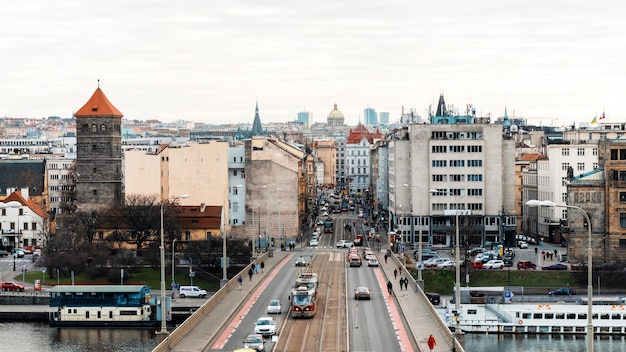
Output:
[[378, 249, 453, 352]]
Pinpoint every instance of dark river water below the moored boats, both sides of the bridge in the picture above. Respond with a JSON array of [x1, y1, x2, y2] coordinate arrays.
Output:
[[0, 323, 626, 352]]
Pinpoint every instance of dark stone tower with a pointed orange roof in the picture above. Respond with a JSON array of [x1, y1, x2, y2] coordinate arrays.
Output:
[[74, 86, 124, 211]]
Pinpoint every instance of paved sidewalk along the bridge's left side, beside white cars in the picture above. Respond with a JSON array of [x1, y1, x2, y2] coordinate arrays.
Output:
[[169, 250, 294, 352]]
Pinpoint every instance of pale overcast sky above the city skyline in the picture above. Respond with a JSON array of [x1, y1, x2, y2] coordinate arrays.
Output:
[[0, 0, 626, 125]]
